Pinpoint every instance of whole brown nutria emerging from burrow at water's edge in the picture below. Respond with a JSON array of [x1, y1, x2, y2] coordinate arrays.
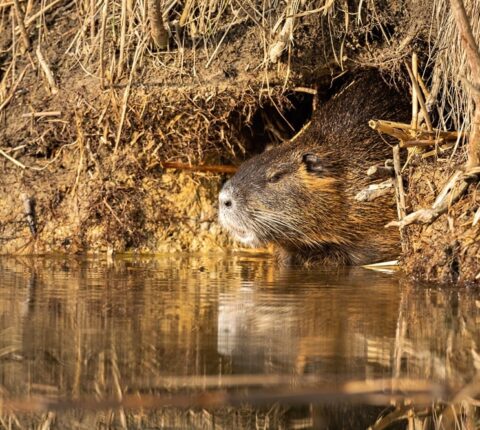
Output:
[[219, 73, 406, 265]]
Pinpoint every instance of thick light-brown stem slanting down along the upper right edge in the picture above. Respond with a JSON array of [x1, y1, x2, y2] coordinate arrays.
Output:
[[450, 0, 480, 169]]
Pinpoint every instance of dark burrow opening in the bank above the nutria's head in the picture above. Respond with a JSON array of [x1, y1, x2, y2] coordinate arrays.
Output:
[[240, 92, 314, 159]]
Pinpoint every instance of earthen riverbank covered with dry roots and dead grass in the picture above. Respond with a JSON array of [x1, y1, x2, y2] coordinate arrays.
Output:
[[0, 0, 480, 281]]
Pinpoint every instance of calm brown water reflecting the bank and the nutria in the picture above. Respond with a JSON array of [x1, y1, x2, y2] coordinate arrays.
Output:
[[0, 255, 480, 429]]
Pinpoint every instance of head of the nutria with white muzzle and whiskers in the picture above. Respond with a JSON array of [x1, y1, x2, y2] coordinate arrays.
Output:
[[219, 143, 350, 250]]
